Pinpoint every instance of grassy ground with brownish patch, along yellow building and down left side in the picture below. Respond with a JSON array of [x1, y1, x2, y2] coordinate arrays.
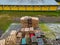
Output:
[[0, 11, 60, 32]]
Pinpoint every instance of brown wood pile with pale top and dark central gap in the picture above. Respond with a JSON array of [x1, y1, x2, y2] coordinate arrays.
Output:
[[20, 16, 39, 28]]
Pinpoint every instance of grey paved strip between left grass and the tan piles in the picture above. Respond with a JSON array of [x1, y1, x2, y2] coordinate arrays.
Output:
[[1, 23, 21, 39]]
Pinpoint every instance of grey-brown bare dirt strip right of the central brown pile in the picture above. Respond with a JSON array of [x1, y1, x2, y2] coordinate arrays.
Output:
[[39, 16, 60, 23]]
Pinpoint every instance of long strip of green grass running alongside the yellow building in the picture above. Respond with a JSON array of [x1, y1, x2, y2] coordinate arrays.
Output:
[[0, 11, 60, 17]]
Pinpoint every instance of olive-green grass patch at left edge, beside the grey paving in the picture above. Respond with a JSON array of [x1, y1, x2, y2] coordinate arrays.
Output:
[[0, 17, 13, 32]]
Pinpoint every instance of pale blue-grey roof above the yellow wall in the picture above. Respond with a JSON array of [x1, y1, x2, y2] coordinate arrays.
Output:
[[0, 0, 58, 5]]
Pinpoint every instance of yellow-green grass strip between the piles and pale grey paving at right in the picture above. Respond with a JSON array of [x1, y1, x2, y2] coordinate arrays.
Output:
[[39, 23, 55, 39]]
